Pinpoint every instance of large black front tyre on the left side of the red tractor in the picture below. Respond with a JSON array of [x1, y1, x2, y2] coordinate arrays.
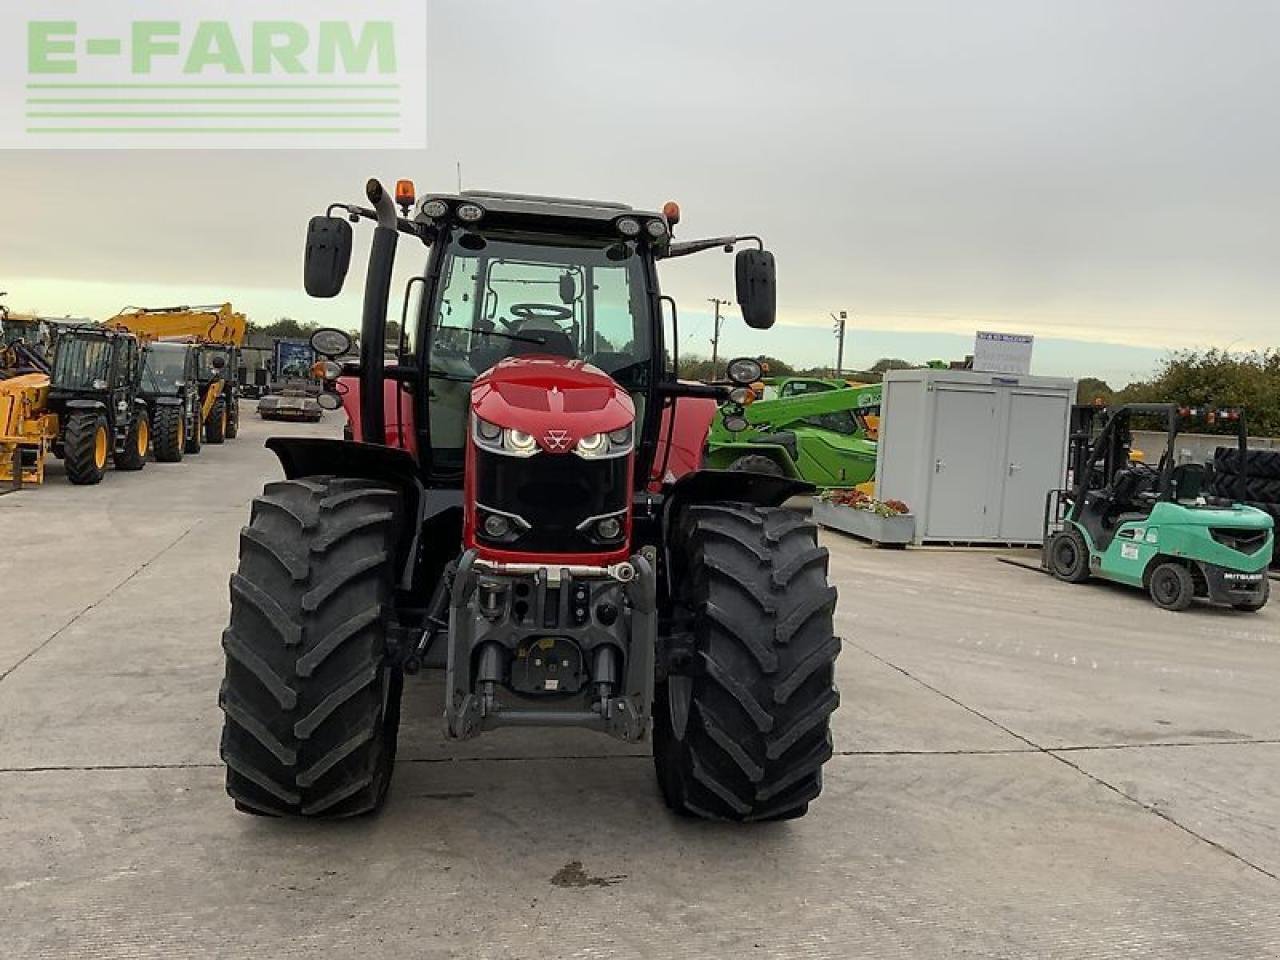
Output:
[[219, 477, 403, 818]]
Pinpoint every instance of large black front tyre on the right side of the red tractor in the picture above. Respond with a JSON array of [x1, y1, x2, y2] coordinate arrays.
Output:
[[654, 503, 840, 820]]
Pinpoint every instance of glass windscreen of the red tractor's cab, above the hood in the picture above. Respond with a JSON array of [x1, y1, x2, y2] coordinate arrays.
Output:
[[428, 234, 655, 461]]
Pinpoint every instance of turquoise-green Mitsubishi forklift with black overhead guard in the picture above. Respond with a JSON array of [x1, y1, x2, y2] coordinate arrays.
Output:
[[1041, 403, 1274, 612]]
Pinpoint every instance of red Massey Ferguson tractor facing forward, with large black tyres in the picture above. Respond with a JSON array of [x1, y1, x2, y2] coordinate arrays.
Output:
[[220, 180, 840, 820]]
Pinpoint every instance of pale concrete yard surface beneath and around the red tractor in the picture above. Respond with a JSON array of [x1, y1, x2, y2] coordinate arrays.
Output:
[[0, 406, 1280, 960]]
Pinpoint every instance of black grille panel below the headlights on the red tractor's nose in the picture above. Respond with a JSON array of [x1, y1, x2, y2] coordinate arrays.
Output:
[[476, 449, 631, 553]]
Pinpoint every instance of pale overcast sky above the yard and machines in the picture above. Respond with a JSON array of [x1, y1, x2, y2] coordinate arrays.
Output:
[[0, 0, 1280, 380]]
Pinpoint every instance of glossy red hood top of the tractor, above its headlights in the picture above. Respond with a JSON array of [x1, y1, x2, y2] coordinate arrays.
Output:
[[471, 356, 636, 453]]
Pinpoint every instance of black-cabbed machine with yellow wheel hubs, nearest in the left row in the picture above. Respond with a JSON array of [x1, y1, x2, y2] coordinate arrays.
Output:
[[49, 324, 151, 484]]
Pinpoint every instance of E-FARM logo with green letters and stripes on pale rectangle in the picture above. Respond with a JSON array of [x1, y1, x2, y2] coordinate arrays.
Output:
[[0, 0, 426, 150]]
